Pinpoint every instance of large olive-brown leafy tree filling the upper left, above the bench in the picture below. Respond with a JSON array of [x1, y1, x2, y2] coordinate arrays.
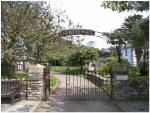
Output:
[[1, 1, 81, 77]]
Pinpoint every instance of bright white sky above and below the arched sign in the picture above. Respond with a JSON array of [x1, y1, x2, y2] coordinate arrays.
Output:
[[47, 0, 147, 49]]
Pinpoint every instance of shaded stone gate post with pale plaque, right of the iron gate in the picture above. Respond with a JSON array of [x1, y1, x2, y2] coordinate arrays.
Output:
[[110, 63, 130, 100]]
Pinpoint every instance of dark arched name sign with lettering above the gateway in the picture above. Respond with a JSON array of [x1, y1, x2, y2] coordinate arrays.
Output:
[[59, 29, 95, 37]]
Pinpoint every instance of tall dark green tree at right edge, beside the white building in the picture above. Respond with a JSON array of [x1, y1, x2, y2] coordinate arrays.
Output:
[[122, 15, 149, 75]]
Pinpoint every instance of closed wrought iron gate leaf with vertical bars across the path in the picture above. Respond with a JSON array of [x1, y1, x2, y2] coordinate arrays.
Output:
[[66, 67, 111, 99]]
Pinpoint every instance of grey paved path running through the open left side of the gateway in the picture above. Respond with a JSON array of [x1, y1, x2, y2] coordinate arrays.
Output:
[[38, 72, 121, 112]]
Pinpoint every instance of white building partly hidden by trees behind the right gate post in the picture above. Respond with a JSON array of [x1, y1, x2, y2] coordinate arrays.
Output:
[[121, 44, 137, 66]]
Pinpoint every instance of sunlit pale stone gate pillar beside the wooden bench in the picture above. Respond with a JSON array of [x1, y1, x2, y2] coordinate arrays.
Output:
[[22, 64, 45, 100]]
